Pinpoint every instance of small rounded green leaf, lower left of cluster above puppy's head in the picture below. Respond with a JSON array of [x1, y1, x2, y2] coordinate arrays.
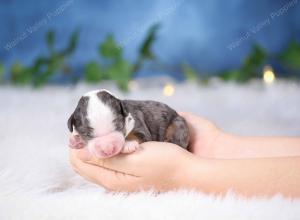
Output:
[[84, 61, 104, 83]]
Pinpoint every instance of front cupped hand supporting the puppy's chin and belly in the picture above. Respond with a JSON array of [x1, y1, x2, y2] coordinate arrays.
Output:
[[70, 142, 193, 192]]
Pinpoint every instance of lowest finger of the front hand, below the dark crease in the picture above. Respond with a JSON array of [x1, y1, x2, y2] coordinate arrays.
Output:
[[70, 152, 140, 191]]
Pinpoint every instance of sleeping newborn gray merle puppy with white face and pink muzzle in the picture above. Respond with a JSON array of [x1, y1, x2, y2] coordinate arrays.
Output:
[[68, 90, 189, 158]]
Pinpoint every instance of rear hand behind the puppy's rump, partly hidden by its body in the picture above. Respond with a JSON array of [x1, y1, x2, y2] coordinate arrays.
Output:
[[179, 112, 223, 158]]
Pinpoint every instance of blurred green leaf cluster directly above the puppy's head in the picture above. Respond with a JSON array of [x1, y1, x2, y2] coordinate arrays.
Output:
[[84, 24, 158, 91]]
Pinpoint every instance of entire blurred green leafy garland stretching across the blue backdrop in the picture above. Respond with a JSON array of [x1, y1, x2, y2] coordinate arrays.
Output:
[[5, 24, 300, 88]]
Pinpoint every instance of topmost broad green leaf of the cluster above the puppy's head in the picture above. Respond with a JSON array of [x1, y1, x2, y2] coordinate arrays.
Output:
[[99, 35, 122, 59]]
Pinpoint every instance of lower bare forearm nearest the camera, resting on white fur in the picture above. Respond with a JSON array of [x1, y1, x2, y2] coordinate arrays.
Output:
[[182, 157, 300, 197]]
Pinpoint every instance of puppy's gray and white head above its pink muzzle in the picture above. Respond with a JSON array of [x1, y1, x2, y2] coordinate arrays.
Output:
[[68, 90, 133, 146]]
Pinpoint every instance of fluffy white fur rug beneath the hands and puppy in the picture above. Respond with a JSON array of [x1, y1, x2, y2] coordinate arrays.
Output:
[[0, 79, 300, 220]]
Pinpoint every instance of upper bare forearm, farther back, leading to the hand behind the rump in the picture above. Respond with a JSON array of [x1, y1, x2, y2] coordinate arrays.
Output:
[[213, 132, 300, 159]]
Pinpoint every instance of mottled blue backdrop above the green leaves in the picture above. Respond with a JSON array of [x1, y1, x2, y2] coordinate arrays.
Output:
[[0, 0, 300, 77]]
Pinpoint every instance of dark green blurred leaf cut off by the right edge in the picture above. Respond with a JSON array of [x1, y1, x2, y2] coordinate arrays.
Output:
[[279, 41, 300, 70]]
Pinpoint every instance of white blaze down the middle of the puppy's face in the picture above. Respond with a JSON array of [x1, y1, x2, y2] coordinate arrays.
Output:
[[84, 90, 115, 136]]
